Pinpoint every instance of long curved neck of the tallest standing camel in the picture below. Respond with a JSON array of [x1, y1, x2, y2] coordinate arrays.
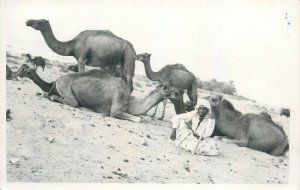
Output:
[[41, 25, 73, 56]]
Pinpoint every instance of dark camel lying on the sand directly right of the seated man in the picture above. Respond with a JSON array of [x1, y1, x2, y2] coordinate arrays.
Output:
[[205, 95, 289, 156]]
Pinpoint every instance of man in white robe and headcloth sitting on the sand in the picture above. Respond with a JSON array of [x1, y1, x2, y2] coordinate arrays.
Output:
[[170, 99, 219, 156]]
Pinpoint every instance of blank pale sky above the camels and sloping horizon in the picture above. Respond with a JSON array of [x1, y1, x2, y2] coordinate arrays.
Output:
[[0, 0, 300, 107]]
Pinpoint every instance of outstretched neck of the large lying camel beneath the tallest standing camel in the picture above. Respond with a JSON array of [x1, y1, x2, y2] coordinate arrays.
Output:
[[128, 89, 164, 115]]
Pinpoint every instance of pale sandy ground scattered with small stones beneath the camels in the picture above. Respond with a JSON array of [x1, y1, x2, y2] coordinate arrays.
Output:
[[6, 50, 289, 184]]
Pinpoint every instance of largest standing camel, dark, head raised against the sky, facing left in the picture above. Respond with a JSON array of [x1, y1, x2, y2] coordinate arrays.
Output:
[[26, 19, 136, 92]]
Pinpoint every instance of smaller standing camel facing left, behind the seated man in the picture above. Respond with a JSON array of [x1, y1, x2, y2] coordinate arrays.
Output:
[[136, 53, 197, 120]]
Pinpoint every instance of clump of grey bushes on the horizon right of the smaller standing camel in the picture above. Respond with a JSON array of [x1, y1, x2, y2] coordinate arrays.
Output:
[[197, 79, 236, 95]]
